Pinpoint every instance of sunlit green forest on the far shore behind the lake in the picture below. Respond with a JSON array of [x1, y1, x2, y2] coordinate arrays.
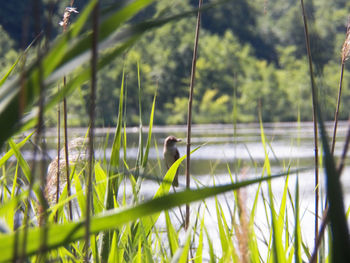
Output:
[[0, 0, 350, 126]]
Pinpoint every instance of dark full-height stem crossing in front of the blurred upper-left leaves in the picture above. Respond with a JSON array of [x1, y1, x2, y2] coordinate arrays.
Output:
[[85, 1, 99, 262]]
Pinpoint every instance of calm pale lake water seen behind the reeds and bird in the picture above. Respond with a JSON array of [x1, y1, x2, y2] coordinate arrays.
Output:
[[15, 122, 350, 260]]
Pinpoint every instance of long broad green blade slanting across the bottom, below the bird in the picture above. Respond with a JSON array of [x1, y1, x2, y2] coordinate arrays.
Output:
[[0, 169, 298, 262]]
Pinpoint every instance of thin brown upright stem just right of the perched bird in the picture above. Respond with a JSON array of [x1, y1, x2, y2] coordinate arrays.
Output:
[[185, 0, 203, 230]]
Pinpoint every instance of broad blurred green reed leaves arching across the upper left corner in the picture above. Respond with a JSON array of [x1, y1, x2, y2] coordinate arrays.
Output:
[[0, 0, 205, 146]]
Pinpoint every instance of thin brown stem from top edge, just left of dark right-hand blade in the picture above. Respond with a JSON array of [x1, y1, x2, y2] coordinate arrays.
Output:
[[300, 0, 319, 256]]
